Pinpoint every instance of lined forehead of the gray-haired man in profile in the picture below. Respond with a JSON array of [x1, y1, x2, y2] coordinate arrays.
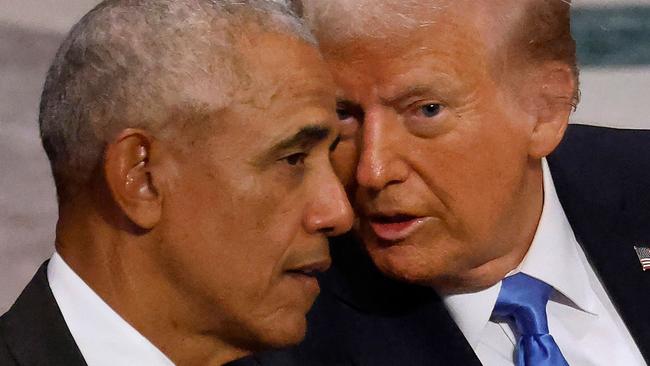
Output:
[[167, 27, 336, 144]]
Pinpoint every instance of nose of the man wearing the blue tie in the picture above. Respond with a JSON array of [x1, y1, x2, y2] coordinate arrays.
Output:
[[357, 110, 408, 191]]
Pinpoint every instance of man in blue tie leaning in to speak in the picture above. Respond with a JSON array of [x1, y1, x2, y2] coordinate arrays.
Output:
[[237, 0, 650, 366]]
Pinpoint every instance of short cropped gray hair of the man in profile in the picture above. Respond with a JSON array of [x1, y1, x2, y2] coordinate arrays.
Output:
[[39, 0, 316, 201]]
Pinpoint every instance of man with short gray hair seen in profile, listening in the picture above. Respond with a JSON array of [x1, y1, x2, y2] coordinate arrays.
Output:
[[0, 0, 352, 366]]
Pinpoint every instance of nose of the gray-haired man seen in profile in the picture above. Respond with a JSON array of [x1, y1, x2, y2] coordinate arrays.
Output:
[[304, 169, 354, 236]]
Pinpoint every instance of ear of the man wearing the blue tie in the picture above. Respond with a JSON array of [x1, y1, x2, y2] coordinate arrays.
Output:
[[528, 61, 576, 159]]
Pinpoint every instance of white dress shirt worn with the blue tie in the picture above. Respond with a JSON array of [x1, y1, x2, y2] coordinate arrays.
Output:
[[444, 160, 646, 366]]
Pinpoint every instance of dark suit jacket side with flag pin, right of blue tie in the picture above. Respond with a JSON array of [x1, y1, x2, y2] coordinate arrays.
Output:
[[549, 126, 650, 362]]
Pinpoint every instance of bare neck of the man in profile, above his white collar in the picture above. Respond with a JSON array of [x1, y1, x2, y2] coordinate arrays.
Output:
[[56, 212, 247, 365]]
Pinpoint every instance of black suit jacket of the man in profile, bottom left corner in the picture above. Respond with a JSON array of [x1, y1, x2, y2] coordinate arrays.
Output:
[[0, 262, 86, 366]]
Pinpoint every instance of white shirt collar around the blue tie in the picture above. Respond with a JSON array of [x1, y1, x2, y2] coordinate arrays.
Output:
[[443, 159, 596, 348]]
